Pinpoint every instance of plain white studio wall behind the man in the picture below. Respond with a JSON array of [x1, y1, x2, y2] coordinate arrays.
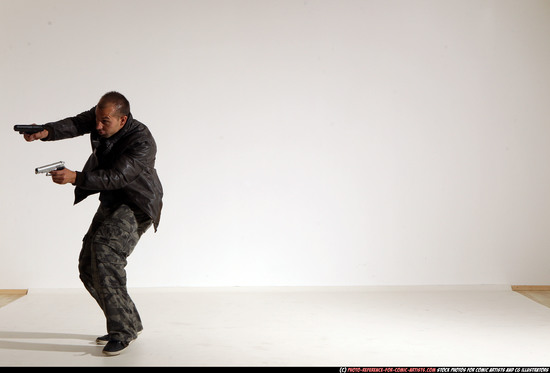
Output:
[[0, 0, 550, 288]]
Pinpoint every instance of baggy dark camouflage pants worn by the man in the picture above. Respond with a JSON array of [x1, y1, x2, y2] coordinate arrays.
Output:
[[78, 204, 151, 341]]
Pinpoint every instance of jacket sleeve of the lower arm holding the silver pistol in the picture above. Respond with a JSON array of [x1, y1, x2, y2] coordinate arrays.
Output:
[[74, 135, 156, 191]]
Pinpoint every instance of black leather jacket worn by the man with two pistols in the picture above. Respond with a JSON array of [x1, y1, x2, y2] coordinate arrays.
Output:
[[44, 107, 163, 231]]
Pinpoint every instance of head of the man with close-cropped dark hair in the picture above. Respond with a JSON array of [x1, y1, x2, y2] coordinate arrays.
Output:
[[95, 92, 130, 138]]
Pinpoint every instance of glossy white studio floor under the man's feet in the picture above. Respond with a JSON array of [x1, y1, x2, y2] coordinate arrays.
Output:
[[0, 286, 550, 367]]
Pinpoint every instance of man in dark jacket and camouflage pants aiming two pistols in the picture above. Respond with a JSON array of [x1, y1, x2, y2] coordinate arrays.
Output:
[[24, 92, 163, 356]]
